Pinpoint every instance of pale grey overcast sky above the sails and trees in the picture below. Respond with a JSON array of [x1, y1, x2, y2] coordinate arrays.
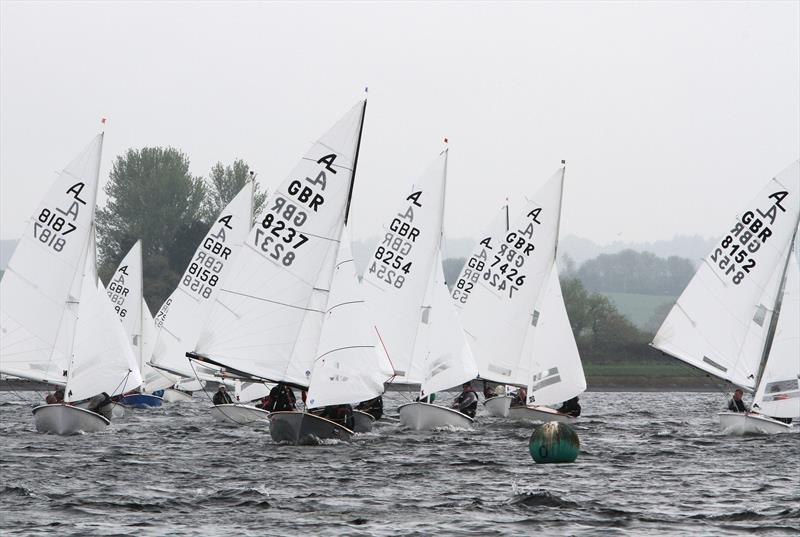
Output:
[[0, 1, 800, 243]]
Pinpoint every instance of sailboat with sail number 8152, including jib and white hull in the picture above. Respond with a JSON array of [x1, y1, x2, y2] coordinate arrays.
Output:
[[651, 160, 800, 434]]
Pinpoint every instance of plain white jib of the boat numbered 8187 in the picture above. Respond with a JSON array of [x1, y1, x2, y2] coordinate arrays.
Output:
[[64, 233, 142, 401]]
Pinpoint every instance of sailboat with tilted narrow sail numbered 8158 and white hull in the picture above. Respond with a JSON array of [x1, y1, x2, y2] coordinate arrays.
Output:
[[147, 181, 253, 418]]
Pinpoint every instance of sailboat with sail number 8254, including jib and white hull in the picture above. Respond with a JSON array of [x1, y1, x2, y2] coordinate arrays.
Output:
[[363, 150, 477, 430]]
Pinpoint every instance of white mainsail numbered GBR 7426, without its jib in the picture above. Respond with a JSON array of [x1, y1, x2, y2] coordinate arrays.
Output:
[[460, 168, 564, 386]]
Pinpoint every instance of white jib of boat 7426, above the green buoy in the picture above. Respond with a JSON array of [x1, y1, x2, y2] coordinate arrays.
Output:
[[523, 263, 586, 405]]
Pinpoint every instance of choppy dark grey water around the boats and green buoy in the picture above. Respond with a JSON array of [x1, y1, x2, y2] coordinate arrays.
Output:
[[0, 393, 800, 536]]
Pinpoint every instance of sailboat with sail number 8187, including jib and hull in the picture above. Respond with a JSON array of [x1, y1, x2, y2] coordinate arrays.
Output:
[[0, 134, 142, 435]]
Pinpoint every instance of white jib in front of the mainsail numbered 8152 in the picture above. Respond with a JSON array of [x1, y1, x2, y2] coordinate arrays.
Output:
[[753, 249, 800, 418]]
